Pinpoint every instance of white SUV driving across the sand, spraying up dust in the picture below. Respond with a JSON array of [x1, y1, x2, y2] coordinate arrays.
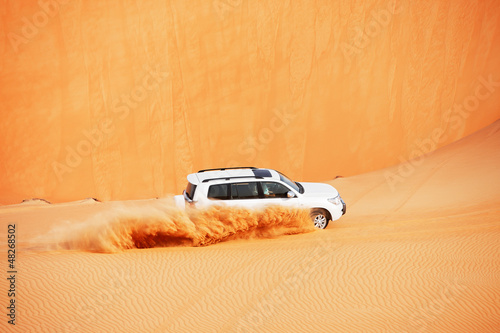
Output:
[[175, 167, 346, 229]]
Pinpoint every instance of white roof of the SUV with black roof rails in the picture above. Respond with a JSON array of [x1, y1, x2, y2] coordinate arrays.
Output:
[[187, 168, 280, 185]]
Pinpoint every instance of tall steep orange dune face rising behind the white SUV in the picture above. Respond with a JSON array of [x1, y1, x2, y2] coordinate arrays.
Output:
[[0, 0, 500, 204]]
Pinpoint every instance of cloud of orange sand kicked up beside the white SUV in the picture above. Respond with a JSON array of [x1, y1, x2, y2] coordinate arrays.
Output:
[[39, 202, 315, 253]]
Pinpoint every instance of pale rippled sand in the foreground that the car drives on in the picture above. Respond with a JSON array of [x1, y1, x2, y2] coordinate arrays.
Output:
[[0, 121, 500, 332]]
